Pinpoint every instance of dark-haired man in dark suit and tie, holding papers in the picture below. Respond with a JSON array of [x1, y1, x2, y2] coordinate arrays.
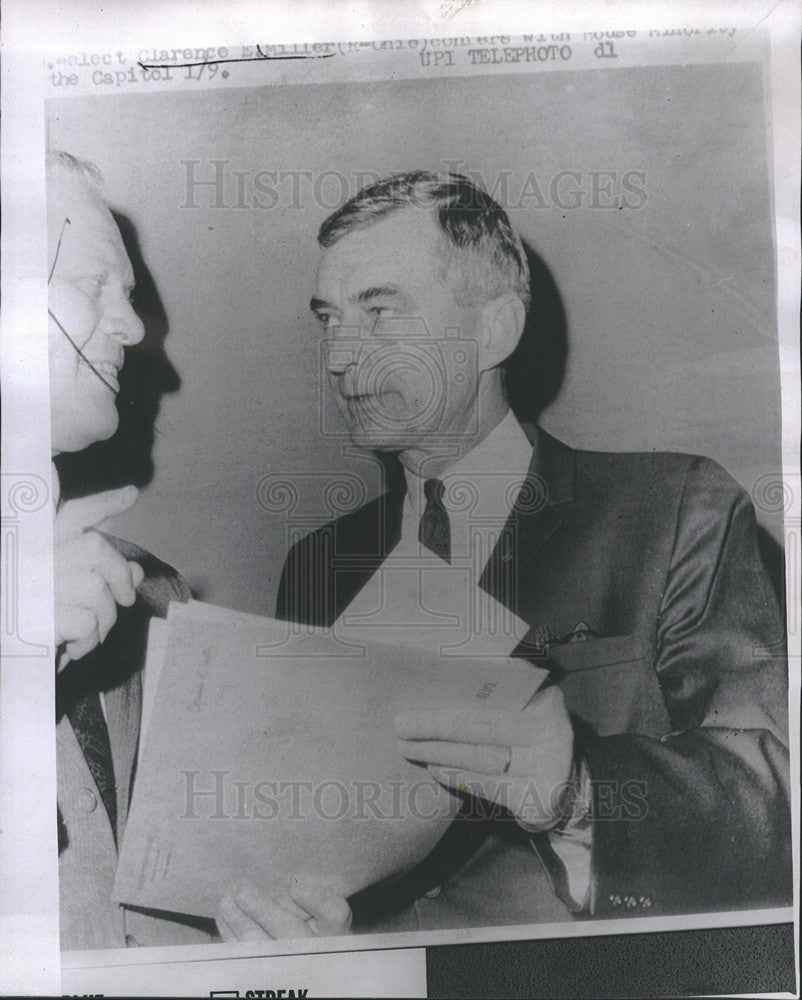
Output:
[[260, 172, 791, 929]]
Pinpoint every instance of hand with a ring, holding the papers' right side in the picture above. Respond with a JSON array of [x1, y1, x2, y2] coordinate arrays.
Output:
[[395, 687, 574, 833]]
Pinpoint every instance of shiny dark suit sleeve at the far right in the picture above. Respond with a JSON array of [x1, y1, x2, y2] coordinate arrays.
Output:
[[576, 460, 792, 916]]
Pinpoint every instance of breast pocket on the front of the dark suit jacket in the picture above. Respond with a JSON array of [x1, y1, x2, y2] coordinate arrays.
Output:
[[548, 635, 671, 738]]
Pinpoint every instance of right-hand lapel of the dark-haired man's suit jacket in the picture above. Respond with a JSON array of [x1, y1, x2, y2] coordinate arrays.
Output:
[[479, 424, 576, 614]]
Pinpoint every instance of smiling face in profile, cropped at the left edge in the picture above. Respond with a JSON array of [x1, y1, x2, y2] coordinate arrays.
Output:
[[48, 172, 144, 453]]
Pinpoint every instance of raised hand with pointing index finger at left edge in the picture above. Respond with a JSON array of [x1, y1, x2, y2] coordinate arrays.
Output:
[[54, 486, 144, 670]]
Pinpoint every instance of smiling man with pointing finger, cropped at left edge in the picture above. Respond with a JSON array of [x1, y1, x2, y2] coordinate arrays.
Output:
[[47, 151, 348, 950]]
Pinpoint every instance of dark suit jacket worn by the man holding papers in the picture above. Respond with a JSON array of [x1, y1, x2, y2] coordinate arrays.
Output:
[[277, 428, 791, 926]]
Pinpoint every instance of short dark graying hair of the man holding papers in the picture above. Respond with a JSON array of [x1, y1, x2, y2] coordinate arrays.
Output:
[[318, 170, 530, 307]]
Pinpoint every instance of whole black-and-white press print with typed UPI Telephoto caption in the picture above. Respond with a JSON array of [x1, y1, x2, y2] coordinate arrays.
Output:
[[3, 4, 800, 996]]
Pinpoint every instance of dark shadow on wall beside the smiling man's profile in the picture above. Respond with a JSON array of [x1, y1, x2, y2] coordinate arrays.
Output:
[[56, 212, 181, 499]]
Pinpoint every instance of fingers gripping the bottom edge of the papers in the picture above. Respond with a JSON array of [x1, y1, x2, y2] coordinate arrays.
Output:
[[215, 879, 352, 941]]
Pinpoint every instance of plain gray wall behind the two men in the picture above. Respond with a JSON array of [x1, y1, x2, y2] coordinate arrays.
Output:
[[48, 64, 782, 614]]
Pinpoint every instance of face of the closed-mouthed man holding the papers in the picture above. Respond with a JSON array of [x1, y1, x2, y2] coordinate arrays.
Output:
[[311, 207, 479, 451]]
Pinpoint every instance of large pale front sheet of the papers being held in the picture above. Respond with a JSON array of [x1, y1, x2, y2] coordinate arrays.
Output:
[[114, 604, 544, 916]]
